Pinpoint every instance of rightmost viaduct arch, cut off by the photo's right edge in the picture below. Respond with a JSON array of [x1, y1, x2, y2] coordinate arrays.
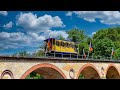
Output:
[[105, 64, 120, 79]]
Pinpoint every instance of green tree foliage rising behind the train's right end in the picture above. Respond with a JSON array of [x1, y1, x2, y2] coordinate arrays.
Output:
[[67, 28, 91, 55]]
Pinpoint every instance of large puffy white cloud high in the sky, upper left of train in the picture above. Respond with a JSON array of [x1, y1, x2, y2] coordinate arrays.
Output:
[[16, 13, 65, 32]]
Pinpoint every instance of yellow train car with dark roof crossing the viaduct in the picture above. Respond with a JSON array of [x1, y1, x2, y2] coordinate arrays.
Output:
[[44, 38, 78, 56]]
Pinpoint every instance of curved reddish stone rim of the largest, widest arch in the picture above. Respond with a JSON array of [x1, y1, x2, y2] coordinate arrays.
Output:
[[21, 63, 66, 79]]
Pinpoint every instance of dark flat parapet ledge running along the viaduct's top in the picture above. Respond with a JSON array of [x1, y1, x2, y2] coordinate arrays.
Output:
[[0, 56, 120, 63]]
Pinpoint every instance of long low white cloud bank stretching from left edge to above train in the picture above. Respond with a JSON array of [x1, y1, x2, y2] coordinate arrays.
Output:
[[0, 30, 68, 49]]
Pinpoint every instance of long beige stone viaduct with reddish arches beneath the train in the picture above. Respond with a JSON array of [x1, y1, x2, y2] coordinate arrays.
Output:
[[0, 56, 120, 79]]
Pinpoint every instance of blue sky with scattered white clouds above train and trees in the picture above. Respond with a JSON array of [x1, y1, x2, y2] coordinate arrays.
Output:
[[0, 11, 120, 55]]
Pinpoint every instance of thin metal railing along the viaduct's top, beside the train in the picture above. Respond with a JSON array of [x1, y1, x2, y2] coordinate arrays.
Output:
[[0, 53, 120, 61]]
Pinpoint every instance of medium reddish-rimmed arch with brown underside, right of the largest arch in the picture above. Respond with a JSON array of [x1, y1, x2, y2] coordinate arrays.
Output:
[[76, 64, 100, 79]]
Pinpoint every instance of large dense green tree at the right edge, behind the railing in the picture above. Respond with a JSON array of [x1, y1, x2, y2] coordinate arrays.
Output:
[[92, 27, 120, 59]]
